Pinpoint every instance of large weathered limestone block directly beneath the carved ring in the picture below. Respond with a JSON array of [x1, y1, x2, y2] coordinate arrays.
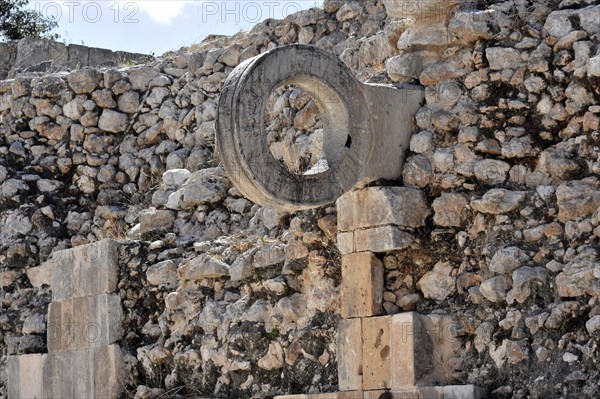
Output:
[[337, 187, 431, 231]]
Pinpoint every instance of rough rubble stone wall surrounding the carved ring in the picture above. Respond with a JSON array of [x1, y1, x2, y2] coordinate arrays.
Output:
[[0, 0, 600, 399]]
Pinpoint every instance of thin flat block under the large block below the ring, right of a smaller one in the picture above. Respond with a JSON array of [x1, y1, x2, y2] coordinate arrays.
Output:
[[354, 225, 414, 252]]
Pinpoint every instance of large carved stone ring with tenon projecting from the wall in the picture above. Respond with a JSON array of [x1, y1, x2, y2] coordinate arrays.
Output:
[[217, 45, 423, 211]]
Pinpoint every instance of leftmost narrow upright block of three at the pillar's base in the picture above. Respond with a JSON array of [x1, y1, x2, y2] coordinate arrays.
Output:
[[337, 319, 363, 391]]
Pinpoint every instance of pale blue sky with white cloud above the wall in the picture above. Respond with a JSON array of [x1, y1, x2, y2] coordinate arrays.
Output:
[[29, 0, 322, 55]]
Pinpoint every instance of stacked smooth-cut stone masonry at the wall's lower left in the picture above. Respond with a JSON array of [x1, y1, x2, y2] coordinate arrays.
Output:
[[7, 240, 123, 399]]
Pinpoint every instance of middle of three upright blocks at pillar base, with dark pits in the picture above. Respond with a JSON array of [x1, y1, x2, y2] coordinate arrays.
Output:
[[362, 316, 393, 391]]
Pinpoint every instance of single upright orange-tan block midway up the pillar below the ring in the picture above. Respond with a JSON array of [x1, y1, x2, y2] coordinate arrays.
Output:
[[340, 252, 383, 318]]
